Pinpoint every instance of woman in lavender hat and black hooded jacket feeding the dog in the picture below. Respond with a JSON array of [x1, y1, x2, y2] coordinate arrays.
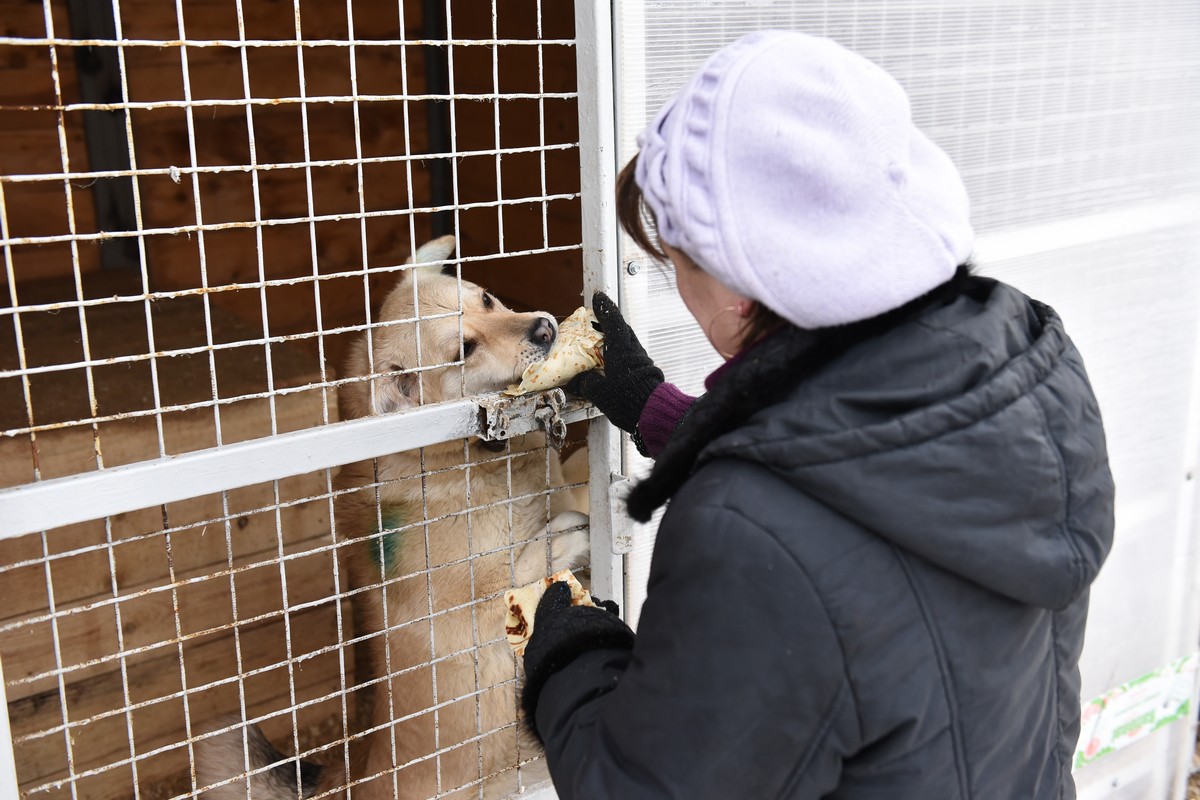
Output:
[[522, 32, 1112, 800]]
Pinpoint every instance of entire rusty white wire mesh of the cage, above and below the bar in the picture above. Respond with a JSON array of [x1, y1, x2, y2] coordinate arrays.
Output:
[[0, 0, 586, 798]]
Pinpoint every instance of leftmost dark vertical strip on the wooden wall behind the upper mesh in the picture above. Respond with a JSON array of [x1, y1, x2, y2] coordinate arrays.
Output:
[[67, 0, 142, 269]]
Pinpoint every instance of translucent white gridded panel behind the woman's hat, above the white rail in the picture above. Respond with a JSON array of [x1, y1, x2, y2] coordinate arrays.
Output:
[[620, 0, 1200, 233]]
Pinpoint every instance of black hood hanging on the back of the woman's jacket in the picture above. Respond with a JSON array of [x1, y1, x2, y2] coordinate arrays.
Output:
[[697, 282, 1114, 609]]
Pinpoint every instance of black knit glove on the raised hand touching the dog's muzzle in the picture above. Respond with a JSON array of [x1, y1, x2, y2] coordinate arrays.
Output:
[[566, 291, 662, 433]]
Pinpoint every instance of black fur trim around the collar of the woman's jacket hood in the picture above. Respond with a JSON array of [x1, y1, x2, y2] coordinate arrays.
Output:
[[626, 264, 991, 522]]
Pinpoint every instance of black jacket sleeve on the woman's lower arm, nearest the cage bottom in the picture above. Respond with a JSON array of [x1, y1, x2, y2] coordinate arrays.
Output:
[[535, 468, 856, 800]]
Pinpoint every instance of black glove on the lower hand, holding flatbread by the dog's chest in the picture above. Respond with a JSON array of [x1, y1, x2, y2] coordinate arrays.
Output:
[[521, 581, 634, 738]]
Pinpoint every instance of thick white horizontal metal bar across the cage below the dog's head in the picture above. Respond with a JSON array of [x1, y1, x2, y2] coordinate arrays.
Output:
[[0, 399, 599, 539]]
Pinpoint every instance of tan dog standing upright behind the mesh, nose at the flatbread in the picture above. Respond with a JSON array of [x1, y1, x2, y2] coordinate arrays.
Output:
[[197, 236, 589, 799]]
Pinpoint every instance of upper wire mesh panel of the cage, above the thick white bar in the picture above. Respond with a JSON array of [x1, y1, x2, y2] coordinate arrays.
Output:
[[0, 0, 580, 485]]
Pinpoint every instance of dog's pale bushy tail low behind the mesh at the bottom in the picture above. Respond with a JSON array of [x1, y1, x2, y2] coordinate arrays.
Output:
[[196, 717, 324, 800]]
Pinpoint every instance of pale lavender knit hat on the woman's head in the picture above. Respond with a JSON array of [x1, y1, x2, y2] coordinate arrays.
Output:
[[636, 31, 974, 329]]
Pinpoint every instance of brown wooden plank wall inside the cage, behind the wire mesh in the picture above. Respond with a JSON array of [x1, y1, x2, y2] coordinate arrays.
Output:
[[0, 0, 581, 799]]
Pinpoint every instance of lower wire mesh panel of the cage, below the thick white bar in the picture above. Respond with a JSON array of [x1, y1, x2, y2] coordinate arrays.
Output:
[[0, 434, 583, 798]]
